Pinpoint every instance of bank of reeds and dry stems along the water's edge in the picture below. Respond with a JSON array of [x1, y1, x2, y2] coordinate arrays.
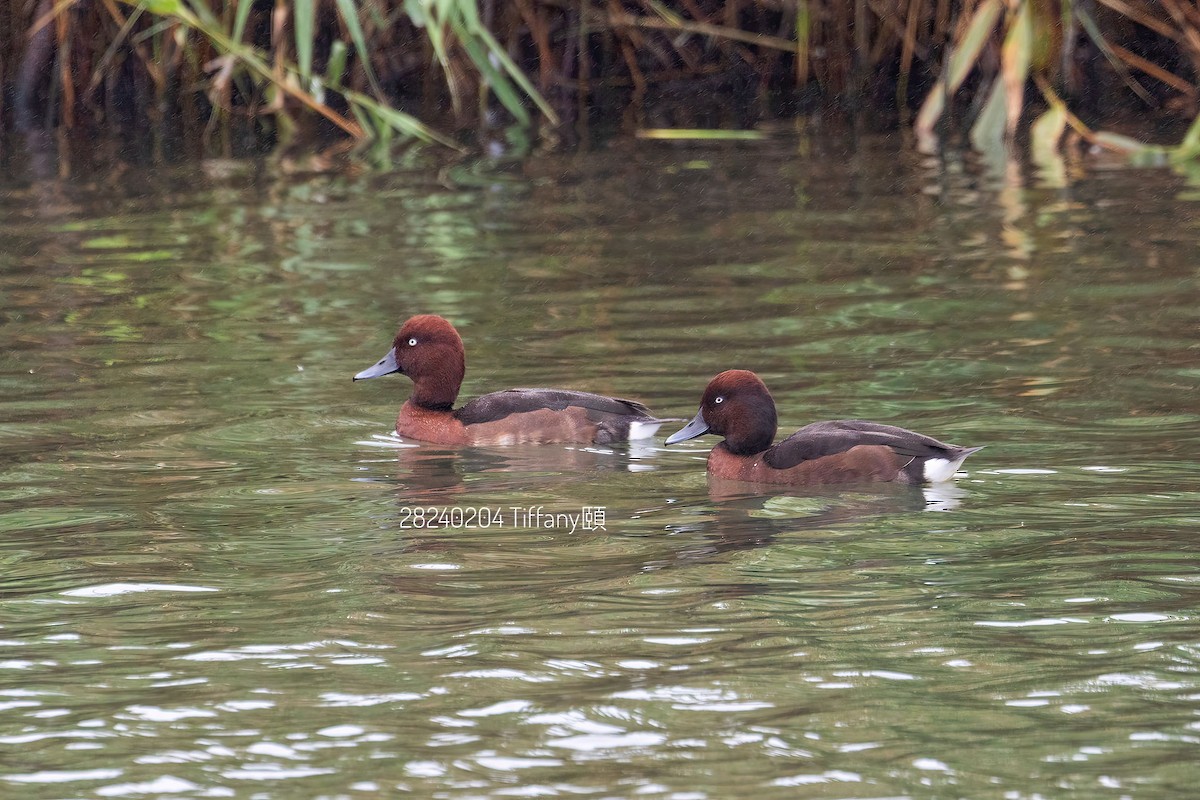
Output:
[[7, 0, 1200, 158]]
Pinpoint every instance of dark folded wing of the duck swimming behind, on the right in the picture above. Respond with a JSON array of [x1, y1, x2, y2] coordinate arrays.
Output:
[[763, 420, 962, 469]]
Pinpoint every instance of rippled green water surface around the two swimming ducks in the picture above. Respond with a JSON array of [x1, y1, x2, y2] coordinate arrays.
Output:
[[0, 138, 1200, 800]]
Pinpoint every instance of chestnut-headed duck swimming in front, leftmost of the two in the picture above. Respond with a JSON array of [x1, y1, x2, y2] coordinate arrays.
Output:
[[354, 314, 666, 445]]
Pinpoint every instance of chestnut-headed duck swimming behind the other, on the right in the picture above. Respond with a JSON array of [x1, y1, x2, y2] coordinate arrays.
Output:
[[667, 369, 982, 486]]
